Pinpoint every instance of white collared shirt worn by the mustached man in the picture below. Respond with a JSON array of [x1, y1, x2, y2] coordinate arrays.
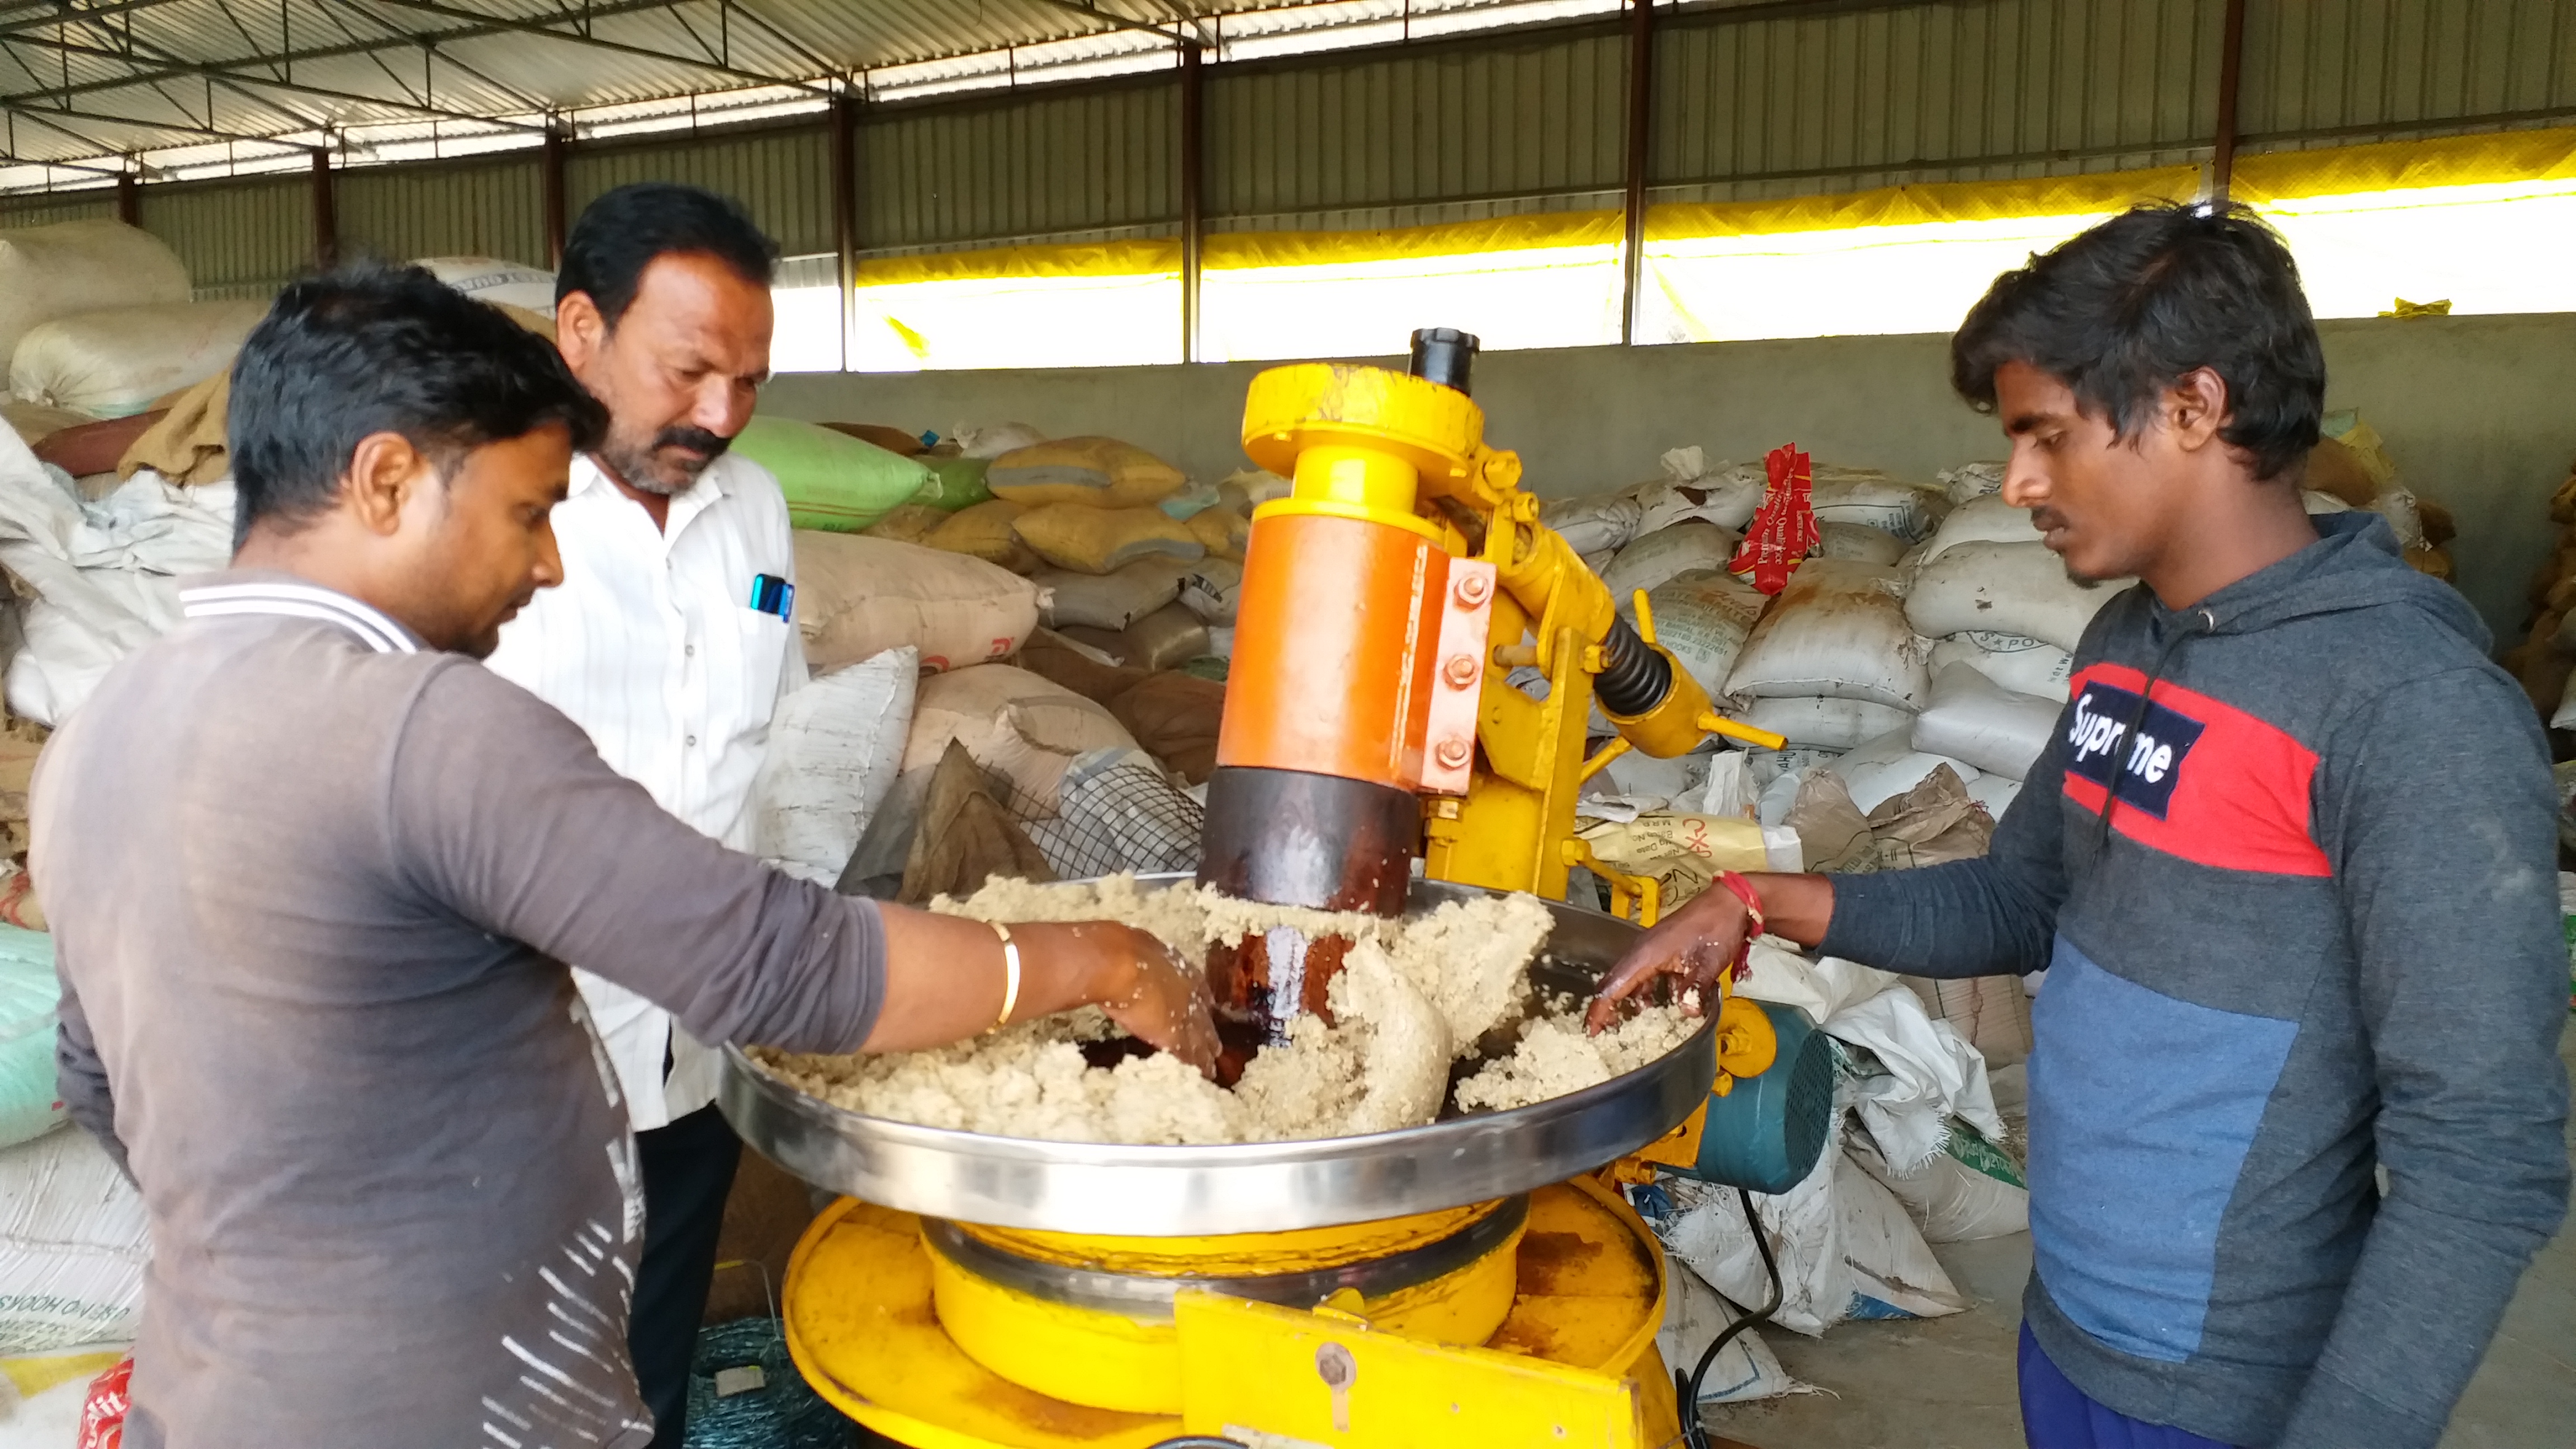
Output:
[[487, 454, 806, 1132]]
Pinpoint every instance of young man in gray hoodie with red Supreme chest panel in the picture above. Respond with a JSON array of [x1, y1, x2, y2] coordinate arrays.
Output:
[[1594, 206, 2568, 1449]]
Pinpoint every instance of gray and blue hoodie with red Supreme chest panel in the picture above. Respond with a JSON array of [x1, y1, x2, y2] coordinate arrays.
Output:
[[1824, 513, 2568, 1449]]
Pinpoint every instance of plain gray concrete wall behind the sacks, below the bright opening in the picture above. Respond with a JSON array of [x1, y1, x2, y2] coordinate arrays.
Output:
[[765, 315, 2576, 642]]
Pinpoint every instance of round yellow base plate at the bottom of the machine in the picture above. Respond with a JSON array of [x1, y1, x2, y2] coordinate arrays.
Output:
[[785, 1178, 1679, 1449]]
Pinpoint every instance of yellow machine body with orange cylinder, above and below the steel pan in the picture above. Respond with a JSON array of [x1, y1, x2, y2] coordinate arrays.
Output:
[[785, 338, 1783, 1449]]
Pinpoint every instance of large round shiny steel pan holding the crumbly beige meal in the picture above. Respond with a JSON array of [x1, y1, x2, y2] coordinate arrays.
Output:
[[719, 877, 1716, 1238]]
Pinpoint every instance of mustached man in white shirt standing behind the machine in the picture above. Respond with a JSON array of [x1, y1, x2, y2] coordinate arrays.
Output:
[[490, 183, 806, 1449]]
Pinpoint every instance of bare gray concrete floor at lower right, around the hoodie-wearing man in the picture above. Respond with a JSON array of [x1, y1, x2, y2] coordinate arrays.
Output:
[[1708, 1024, 2576, 1449]]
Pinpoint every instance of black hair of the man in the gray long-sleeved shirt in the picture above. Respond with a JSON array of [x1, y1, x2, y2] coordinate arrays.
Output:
[[227, 261, 608, 547]]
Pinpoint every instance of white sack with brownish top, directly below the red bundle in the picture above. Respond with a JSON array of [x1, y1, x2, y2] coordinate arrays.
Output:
[[1726, 560, 1932, 709]]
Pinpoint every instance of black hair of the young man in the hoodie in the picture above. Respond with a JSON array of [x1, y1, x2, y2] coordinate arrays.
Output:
[[1950, 201, 2326, 477]]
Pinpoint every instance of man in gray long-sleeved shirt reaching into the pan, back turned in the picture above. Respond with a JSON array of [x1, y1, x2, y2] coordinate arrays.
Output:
[[34, 268, 1213, 1449]]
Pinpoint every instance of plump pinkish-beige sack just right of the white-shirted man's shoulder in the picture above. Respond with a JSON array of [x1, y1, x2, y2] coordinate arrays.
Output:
[[796, 528, 1038, 673]]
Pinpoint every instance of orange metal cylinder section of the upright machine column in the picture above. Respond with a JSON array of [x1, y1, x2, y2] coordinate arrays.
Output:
[[1216, 510, 1450, 792]]
